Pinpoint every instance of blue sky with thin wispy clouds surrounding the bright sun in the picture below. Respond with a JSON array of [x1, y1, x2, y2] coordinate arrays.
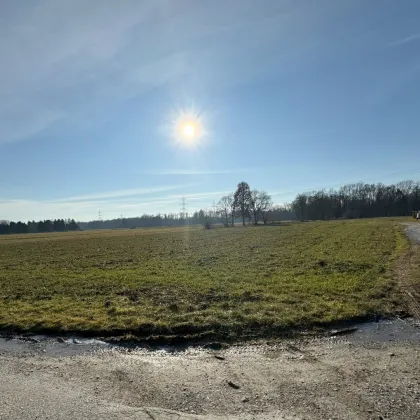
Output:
[[0, 0, 420, 220]]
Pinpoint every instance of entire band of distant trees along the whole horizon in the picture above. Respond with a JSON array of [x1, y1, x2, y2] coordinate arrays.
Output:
[[0, 181, 420, 235]]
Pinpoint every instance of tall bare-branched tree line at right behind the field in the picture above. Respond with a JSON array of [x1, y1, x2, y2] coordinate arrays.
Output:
[[291, 181, 420, 220]]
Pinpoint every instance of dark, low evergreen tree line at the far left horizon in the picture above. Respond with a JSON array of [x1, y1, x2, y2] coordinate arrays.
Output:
[[0, 219, 79, 235]]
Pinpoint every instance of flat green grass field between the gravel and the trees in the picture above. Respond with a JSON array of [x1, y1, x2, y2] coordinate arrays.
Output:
[[0, 219, 414, 337]]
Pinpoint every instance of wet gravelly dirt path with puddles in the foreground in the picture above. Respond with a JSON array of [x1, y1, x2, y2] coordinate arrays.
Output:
[[0, 320, 420, 420]]
